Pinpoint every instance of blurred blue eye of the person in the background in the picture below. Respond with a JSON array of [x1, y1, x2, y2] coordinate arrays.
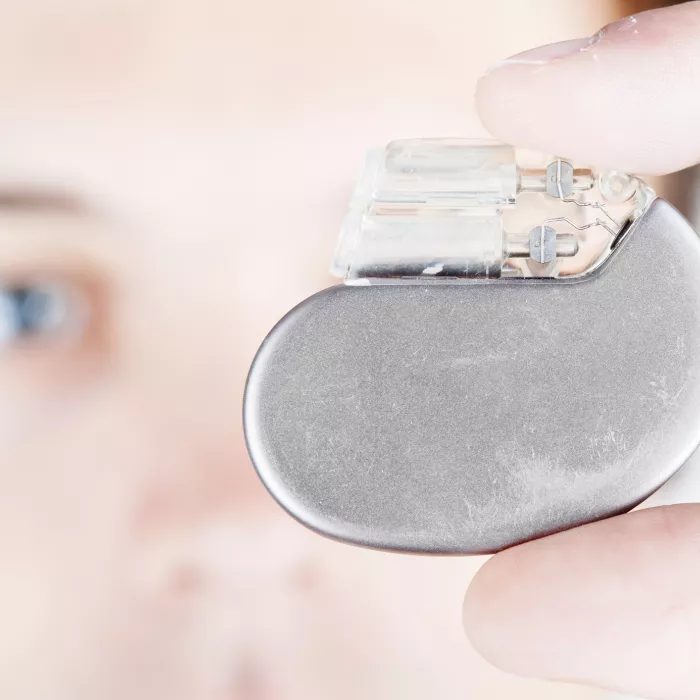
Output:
[[0, 281, 89, 351]]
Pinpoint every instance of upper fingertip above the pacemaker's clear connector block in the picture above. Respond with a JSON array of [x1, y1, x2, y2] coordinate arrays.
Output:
[[476, 1, 700, 174]]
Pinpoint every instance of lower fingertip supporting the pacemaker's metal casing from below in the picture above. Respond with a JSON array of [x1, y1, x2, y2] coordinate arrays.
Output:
[[465, 505, 700, 700]]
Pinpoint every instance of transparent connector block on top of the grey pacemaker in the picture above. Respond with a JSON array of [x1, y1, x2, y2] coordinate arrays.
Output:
[[332, 139, 655, 284]]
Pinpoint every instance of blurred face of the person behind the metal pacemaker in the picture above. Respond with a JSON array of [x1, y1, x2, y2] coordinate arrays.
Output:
[[0, 0, 616, 700]]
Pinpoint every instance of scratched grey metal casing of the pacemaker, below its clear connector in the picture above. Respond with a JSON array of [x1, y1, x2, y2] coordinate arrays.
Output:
[[244, 201, 700, 553]]
